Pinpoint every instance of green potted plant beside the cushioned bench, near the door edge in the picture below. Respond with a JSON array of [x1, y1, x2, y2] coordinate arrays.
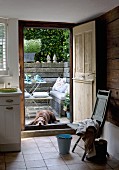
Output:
[[63, 93, 70, 119]]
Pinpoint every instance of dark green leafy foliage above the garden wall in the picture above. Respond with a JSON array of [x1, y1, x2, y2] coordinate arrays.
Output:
[[24, 28, 70, 62]]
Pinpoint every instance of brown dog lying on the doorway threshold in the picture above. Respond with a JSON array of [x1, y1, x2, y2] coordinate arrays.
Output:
[[29, 110, 59, 125]]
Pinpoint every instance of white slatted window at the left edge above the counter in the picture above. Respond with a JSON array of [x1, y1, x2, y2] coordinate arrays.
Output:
[[0, 18, 8, 75]]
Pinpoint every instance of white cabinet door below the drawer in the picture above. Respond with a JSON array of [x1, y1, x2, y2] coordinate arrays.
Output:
[[0, 105, 20, 144]]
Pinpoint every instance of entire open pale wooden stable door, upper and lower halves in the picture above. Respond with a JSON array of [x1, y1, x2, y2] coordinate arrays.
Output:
[[73, 21, 96, 122]]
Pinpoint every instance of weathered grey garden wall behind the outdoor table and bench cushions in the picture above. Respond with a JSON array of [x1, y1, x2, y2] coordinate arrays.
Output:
[[24, 62, 70, 91]]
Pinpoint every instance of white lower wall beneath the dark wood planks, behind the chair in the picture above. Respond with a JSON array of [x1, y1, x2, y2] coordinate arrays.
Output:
[[103, 122, 119, 160]]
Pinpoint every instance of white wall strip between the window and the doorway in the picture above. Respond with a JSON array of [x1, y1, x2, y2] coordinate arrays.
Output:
[[0, 19, 19, 87]]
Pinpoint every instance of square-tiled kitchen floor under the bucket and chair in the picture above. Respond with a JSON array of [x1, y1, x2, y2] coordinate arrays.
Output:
[[0, 135, 119, 170]]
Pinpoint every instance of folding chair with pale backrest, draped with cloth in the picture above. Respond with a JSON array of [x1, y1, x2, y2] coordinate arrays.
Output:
[[68, 90, 110, 161]]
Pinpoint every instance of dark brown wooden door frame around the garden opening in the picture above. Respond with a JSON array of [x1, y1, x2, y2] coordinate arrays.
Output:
[[19, 21, 73, 130]]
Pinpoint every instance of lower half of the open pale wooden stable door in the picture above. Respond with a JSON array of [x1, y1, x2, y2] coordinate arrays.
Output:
[[74, 79, 93, 122]]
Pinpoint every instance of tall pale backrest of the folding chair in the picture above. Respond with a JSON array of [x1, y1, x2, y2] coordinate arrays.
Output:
[[91, 90, 110, 131]]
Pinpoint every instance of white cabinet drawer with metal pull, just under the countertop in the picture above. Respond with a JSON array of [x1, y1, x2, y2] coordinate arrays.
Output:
[[0, 96, 20, 106]]
